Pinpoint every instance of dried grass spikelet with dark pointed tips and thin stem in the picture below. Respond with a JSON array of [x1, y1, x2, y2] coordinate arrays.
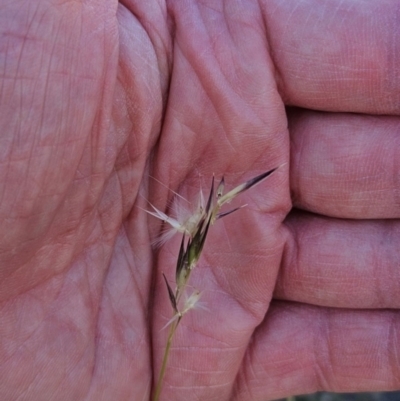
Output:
[[147, 168, 277, 401]]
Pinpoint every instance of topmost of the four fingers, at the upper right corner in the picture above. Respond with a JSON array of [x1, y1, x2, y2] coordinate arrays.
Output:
[[261, 0, 400, 114]]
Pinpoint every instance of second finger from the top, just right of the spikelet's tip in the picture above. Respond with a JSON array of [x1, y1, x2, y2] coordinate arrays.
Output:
[[289, 110, 400, 219]]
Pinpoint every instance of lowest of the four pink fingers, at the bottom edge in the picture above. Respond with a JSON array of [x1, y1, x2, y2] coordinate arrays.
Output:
[[233, 303, 400, 401]]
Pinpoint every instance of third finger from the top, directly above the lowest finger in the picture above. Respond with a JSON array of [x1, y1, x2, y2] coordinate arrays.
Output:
[[275, 213, 400, 308]]
